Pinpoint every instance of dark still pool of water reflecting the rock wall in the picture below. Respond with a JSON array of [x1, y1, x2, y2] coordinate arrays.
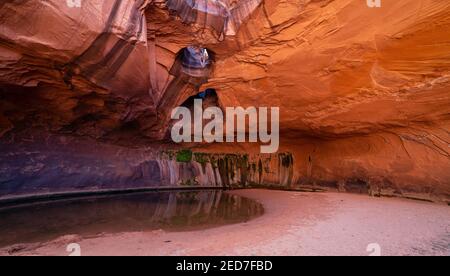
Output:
[[0, 191, 264, 247]]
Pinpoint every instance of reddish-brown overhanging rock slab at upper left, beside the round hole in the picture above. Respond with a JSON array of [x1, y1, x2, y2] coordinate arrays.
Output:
[[0, 0, 155, 140]]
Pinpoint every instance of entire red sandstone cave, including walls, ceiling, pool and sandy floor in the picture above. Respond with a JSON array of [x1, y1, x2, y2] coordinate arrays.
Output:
[[0, 0, 450, 256]]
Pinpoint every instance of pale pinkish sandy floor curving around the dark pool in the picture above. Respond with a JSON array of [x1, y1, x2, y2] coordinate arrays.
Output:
[[0, 190, 450, 255]]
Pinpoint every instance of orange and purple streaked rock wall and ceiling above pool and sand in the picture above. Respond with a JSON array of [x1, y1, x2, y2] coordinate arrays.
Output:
[[0, 0, 450, 201]]
